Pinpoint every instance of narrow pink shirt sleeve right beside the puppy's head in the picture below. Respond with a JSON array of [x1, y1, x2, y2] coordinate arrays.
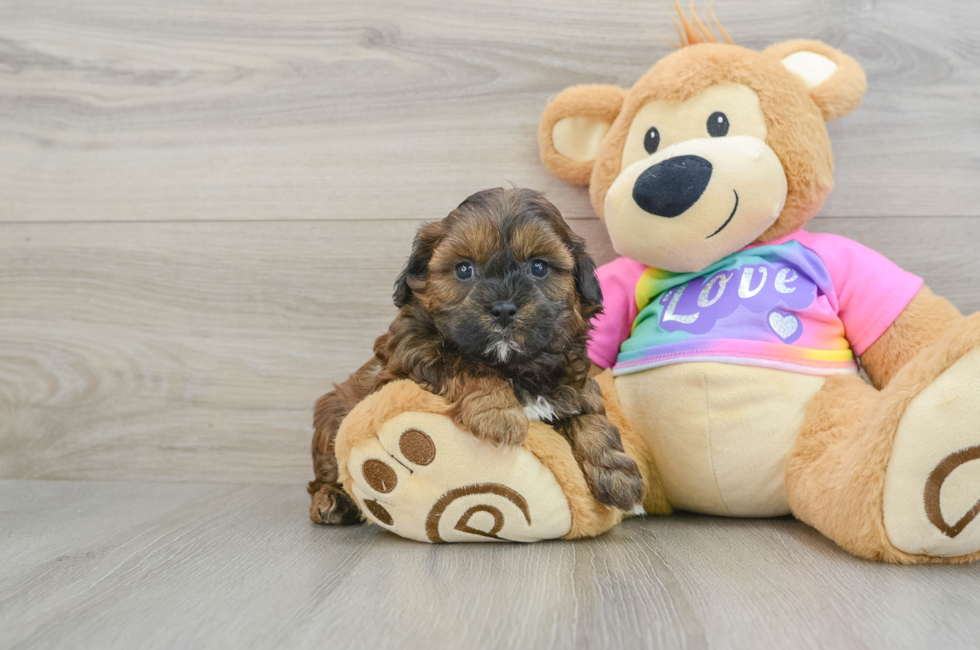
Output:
[[589, 257, 647, 368]]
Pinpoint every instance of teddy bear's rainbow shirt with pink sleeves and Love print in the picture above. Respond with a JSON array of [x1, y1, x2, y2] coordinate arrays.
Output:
[[589, 231, 922, 375]]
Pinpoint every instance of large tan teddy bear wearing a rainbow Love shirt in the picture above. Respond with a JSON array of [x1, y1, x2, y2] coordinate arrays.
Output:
[[326, 6, 980, 564]]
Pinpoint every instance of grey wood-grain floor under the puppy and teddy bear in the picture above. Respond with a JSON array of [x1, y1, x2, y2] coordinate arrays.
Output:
[[0, 481, 980, 650]]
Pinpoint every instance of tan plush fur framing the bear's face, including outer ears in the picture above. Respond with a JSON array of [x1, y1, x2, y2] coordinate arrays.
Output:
[[539, 36, 866, 242]]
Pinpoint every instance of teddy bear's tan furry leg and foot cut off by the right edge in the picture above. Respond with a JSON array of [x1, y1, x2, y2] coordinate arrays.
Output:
[[786, 316, 980, 563]]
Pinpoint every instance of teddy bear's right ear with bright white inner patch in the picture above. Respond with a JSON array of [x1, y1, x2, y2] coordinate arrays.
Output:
[[764, 40, 868, 122]]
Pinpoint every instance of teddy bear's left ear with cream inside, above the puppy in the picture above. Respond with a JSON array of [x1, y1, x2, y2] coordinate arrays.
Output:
[[538, 86, 626, 185]]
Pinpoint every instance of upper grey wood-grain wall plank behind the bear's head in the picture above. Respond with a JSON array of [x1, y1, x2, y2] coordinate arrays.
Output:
[[0, 0, 980, 221]]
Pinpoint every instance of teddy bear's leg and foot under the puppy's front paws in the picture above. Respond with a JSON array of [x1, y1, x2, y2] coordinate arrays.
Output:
[[336, 381, 636, 542]]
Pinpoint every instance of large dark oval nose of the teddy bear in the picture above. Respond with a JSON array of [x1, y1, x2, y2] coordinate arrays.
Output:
[[633, 156, 711, 218]]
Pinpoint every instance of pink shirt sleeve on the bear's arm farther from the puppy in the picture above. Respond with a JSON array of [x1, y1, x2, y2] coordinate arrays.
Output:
[[799, 233, 922, 357]]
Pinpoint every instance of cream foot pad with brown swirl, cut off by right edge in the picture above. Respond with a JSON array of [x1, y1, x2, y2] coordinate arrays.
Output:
[[883, 350, 980, 557]]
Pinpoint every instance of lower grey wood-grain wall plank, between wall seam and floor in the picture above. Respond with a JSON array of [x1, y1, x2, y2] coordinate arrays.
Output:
[[0, 218, 980, 483]]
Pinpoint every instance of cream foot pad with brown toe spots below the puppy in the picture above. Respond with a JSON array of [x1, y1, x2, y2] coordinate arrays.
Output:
[[347, 412, 572, 543]]
